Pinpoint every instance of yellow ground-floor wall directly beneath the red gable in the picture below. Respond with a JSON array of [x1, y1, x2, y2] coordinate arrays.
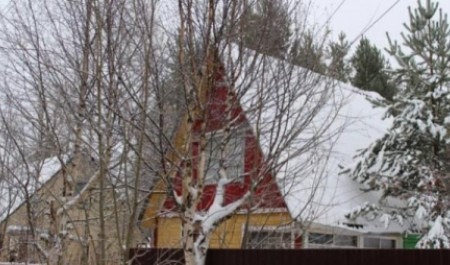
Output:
[[156, 212, 292, 248]]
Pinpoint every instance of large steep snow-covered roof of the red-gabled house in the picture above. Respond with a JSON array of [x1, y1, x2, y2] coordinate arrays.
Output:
[[221, 45, 404, 233]]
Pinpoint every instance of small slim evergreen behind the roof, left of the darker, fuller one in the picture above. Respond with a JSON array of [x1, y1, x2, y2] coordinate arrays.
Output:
[[327, 32, 352, 82]]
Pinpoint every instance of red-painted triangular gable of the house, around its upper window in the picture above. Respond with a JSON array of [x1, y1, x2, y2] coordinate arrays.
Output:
[[163, 64, 286, 212]]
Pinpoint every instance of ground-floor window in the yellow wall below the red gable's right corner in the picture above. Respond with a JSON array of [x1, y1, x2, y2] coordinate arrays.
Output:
[[246, 230, 293, 249]]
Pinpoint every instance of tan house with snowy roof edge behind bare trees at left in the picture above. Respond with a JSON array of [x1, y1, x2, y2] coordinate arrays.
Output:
[[0, 150, 141, 264]]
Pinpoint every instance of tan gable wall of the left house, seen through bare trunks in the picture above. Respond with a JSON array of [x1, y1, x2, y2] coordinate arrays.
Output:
[[0, 154, 143, 265]]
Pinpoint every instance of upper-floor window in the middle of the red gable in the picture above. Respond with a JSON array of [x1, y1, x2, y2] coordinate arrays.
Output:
[[205, 130, 245, 183]]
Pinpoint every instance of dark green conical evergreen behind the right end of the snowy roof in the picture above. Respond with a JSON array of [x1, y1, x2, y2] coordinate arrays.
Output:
[[351, 37, 395, 100]]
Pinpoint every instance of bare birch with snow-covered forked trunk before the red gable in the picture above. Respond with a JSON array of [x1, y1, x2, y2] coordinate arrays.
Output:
[[146, 1, 342, 264]]
